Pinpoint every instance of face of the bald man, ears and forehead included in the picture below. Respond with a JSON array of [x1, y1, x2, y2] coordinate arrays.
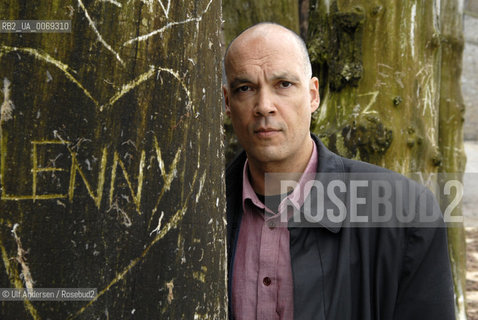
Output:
[[223, 31, 319, 169]]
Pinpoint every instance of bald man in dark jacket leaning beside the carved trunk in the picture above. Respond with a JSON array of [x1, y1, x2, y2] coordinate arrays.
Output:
[[223, 23, 454, 320]]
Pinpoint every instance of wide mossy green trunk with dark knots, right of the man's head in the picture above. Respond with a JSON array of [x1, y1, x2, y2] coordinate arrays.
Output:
[[308, 1, 438, 172]]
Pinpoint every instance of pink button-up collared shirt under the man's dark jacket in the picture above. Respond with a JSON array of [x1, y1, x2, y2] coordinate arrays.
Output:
[[232, 143, 317, 320]]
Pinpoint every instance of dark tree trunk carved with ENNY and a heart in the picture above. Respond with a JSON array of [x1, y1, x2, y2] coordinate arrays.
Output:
[[0, 0, 227, 319]]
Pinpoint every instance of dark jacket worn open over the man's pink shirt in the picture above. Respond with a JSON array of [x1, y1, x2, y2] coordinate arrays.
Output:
[[226, 137, 455, 320]]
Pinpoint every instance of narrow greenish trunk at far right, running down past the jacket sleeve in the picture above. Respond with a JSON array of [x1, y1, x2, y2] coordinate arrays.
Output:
[[439, 0, 466, 319]]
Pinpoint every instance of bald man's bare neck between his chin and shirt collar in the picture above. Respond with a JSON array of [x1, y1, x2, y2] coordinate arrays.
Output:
[[248, 138, 315, 195]]
